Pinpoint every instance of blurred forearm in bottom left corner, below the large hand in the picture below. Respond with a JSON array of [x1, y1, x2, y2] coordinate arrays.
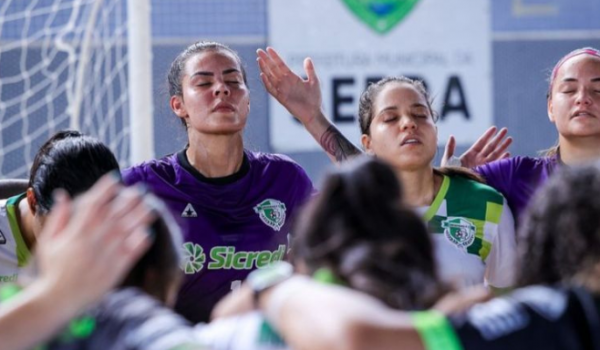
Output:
[[0, 281, 79, 350]]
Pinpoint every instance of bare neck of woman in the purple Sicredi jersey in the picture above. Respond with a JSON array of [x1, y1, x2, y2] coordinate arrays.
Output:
[[185, 133, 244, 177]]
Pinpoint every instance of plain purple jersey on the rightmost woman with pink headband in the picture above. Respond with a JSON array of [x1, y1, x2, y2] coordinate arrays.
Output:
[[475, 156, 560, 223]]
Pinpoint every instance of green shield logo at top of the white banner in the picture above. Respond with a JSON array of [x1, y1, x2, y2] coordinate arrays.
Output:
[[343, 0, 419, 34]]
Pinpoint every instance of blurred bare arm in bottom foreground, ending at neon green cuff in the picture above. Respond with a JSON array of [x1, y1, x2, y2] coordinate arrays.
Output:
[[260, 278, 423, 350]]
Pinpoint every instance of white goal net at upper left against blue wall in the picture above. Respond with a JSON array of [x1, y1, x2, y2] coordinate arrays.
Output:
[[0, 0, 151, 178]]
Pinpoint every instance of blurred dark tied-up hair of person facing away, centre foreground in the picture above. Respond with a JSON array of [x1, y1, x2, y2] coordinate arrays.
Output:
[[294, 156, 446, 310]]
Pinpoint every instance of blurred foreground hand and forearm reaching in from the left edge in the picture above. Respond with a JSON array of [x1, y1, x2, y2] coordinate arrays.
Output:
[[0, 176, 155, 350]]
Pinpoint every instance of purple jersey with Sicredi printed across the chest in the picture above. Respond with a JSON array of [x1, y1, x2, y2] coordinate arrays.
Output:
[[123, 150, 313, 322]]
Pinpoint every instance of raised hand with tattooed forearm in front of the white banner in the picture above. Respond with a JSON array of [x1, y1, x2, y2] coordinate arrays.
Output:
[[257, 47, 362, 163]]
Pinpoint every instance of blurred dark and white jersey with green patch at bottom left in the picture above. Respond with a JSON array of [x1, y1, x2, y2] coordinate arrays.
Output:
[[0, 286, 204, 350]]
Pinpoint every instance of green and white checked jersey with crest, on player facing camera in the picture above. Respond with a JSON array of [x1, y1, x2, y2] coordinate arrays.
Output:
[[421, 176, 517, 288]]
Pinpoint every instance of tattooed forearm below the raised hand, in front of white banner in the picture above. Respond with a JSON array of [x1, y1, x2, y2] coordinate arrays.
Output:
[[304, 111, 362, 163]]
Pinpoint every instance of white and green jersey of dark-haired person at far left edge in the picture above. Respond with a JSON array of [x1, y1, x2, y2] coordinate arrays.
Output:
[[0, 194, 30, 284]]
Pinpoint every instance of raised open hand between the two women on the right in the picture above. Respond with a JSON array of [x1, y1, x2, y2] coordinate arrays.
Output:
[[441, 126, 512, 168]]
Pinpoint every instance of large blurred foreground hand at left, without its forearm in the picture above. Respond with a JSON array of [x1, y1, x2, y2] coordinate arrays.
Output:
[[36, 176, 156, 308]]
